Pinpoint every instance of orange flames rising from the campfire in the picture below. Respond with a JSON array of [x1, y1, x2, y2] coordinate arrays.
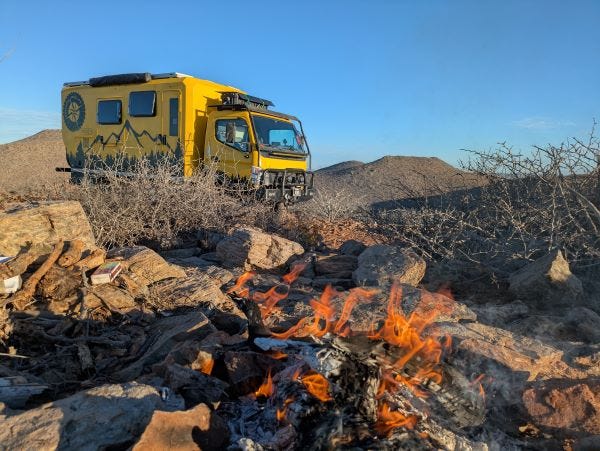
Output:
[[231, 266, 466, 436]]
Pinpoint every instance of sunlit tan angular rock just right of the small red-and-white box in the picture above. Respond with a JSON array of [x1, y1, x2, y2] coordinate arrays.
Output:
[[109, 246, 186, 285]]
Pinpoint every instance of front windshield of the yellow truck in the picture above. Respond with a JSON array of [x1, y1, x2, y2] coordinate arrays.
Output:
[[252, 114, 306, 153]]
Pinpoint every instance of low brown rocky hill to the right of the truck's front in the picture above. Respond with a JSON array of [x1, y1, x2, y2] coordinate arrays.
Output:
[[315, 156, 481, 205]]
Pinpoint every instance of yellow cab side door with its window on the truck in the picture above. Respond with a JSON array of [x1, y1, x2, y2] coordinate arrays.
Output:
[[207, 111, 254, 179]]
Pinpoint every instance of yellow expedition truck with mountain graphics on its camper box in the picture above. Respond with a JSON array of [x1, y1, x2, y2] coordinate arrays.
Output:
[[57, 73, 313, 202]]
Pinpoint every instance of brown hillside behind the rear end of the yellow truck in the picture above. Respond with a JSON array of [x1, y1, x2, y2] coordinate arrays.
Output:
[[0, 130, 68, 192]]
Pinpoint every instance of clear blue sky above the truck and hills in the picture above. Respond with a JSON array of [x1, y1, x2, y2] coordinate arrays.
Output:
[[0, 0, 600, 167]]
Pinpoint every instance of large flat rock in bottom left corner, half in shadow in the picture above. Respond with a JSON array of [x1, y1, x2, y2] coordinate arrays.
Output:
[[0, 382, 167, 451]]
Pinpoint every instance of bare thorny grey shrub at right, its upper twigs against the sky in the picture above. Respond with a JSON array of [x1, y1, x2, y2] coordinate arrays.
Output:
[[374, 129, 600, 272]]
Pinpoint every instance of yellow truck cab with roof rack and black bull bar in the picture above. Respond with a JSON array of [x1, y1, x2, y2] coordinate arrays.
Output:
[[204, 92, 313, 202]]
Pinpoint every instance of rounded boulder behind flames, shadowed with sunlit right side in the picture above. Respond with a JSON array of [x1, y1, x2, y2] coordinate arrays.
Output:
[[352, 244, 426, 286]]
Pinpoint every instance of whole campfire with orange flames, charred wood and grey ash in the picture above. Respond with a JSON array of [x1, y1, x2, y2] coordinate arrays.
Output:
[[222, 265, 485, 449]]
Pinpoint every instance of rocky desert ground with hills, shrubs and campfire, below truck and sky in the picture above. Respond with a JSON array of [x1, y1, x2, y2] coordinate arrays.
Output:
[[0, 130, 600, 450]]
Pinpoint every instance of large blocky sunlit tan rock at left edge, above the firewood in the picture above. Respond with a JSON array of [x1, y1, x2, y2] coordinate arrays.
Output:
[[0, 201, 96, 256]]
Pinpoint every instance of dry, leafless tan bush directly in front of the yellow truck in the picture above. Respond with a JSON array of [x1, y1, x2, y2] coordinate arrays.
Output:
[[63, 159, 265, 248]]
